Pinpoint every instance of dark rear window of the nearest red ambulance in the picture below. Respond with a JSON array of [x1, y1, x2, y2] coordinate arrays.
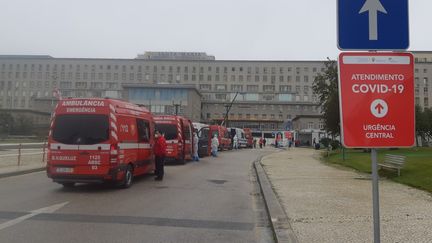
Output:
[[52, 115, 109, 144]]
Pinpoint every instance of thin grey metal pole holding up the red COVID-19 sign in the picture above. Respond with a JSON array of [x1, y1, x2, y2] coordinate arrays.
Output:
[[371, 149, 381, 243]]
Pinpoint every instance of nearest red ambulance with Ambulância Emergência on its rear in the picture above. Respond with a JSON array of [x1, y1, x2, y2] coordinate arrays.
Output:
[[47, 98, 155, 188]]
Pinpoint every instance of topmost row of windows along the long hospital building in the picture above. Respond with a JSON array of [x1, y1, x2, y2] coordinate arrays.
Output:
[[1, 63, 324, 74]]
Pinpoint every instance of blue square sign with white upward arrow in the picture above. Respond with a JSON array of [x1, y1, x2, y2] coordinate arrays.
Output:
[[337, 0, 409, 50]]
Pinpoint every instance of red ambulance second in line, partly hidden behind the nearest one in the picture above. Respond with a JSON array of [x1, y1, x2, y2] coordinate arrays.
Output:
[[154, 115, 193, 164]]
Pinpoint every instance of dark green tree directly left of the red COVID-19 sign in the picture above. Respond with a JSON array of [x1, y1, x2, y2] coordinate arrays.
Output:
[[312, 59, 340, 136]]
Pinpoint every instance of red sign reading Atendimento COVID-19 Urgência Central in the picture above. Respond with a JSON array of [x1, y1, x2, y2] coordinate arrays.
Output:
[[339, 52, 415, 148]]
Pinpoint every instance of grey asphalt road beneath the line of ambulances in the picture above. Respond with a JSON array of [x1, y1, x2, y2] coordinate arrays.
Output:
[[0, 149, 272, 243]]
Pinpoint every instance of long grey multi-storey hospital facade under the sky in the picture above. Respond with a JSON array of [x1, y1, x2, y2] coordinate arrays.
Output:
[[0, 52, 432, 130]]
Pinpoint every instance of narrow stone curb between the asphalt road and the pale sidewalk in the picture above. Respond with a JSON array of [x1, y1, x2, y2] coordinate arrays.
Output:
[[253, 156, 298, 243]]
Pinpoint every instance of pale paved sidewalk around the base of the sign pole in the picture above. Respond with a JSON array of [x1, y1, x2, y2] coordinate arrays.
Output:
[[261, 148, 432, 243]]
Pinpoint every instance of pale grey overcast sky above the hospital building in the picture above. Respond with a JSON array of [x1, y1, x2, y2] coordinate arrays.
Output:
[[0, 0, 432, 60]]
